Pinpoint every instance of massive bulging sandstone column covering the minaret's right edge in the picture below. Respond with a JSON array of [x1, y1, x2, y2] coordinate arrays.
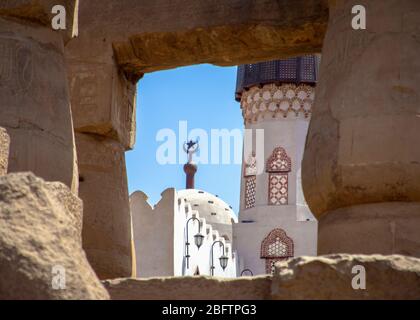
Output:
[[302, 0, 420, 256]]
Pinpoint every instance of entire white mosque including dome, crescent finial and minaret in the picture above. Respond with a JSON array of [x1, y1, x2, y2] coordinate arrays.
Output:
[[130, 56, 319, 277]]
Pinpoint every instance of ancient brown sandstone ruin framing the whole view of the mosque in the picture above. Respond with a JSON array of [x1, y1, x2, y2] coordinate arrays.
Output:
[[0, 0, 420, 299]]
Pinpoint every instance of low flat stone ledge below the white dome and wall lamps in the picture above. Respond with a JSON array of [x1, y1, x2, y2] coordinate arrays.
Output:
[[102, 276, 271, 300]]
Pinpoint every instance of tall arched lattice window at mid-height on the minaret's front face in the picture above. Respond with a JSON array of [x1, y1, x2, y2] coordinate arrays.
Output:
[[266, 147, 292, 205]]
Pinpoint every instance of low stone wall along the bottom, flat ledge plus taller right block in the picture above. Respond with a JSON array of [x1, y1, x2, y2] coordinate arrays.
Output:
[[103, 255, 420, 300]]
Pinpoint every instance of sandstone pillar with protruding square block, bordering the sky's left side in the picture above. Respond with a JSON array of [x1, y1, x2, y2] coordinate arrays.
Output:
[[66, 38, 136, 279]]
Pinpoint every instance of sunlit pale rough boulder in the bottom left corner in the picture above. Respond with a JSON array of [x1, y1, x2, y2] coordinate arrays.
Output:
[[0, 173, 109, 299]]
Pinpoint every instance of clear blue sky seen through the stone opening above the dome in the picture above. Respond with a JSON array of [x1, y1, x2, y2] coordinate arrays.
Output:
[[126, 65, 243, 213]]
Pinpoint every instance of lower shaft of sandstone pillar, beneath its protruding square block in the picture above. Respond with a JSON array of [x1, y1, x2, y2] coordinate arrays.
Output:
[[76, 133, 132, 279]]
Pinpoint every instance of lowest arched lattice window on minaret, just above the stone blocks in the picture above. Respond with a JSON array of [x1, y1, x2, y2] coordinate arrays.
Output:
[[261, 228, 293, 274]]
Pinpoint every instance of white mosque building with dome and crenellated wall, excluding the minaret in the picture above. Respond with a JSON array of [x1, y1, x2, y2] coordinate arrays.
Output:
[[130, 165, 238, 278]]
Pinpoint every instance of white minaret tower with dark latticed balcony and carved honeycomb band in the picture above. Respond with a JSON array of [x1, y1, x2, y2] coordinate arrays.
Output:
[[233, 56, 320, 275]]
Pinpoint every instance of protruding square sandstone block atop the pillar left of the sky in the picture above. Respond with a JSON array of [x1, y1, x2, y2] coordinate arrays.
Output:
[[66, 60, 136, 149]]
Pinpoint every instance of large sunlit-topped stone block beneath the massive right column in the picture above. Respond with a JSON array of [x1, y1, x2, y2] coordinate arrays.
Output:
[[272, 254, 420, 300]]
